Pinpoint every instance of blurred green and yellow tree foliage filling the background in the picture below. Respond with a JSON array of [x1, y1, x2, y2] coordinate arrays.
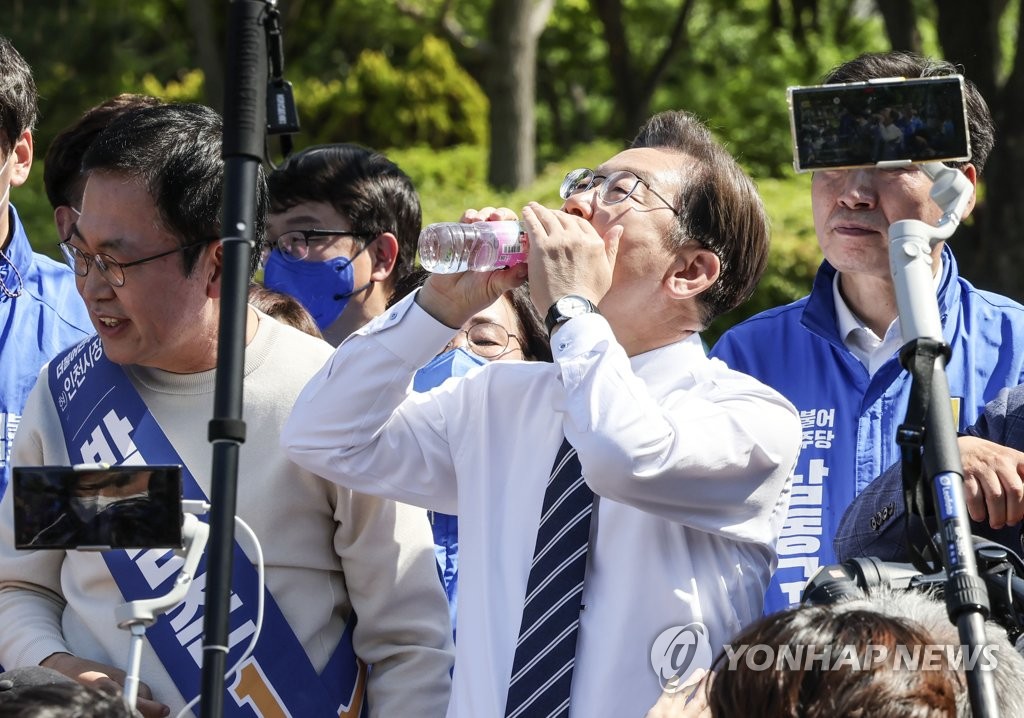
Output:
[[6, 0, 1020, 337]]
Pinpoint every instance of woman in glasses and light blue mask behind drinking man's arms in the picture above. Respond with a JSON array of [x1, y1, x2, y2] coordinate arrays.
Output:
[[388, 269, 551, 635]]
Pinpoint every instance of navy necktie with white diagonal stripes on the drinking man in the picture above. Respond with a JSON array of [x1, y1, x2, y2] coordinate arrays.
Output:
[[505, 439, 594, 718]]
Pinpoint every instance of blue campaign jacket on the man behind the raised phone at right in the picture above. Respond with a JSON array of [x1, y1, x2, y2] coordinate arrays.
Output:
[[711, 247, 1024, 613]]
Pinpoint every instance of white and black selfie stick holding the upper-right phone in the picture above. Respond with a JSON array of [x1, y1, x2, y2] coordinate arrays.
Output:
[[889, 162, 998, 718]]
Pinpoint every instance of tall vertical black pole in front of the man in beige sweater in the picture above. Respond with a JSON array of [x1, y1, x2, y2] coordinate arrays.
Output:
[[201, 0, 267, 718]]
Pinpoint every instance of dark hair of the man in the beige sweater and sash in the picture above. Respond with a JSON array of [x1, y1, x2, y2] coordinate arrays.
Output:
[[82, 103, 267, 278]]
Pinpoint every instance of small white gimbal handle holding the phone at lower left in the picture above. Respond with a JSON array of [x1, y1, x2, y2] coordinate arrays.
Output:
[[114, 513, 210, 710]]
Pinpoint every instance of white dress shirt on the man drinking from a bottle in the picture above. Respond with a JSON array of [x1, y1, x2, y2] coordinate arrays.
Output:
[[283, 294, 800, 718]]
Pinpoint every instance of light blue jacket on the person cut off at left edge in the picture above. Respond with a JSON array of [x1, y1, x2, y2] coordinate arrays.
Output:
[[0, 205, 93, 496]]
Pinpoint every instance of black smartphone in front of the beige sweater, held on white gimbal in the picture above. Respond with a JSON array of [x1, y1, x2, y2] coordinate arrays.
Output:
[[10, 466, 182, 550]]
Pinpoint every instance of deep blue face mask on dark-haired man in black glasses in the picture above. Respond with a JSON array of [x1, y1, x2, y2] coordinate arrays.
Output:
[[263, 244, 373, 331]]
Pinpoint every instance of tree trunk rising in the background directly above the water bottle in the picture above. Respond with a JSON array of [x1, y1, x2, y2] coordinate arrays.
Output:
[[484, 0, 552, 189]]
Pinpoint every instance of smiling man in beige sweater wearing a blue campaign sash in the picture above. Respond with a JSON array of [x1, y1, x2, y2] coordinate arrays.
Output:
[[0, 104, 453, 718]]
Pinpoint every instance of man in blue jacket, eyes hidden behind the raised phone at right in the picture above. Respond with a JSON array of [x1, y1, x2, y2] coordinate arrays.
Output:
[[712, 52, 1024, 613]]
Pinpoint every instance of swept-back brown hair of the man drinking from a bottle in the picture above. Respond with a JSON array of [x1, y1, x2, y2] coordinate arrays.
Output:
[[631, 111, 770, 327]]
